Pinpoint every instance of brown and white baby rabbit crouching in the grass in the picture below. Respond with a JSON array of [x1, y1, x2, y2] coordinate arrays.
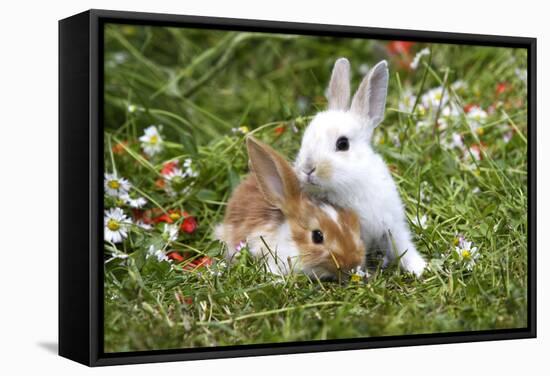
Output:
[[216, 137, 365, 279]]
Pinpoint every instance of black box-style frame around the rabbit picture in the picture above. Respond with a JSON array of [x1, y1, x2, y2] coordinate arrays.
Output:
[[59, 10, 537, 366]]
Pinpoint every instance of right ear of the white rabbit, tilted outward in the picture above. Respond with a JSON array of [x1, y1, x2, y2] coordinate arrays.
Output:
[[350, 60, 388, 128]]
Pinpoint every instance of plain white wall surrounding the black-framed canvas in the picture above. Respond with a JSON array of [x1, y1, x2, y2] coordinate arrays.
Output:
[[0, 0, 550, 376]]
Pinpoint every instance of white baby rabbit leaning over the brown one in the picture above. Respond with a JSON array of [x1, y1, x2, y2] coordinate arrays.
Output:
[[295, 58, 426, 276]]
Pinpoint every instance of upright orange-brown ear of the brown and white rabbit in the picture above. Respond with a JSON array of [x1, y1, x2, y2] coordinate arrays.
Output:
[[246, 136, 300, 215]]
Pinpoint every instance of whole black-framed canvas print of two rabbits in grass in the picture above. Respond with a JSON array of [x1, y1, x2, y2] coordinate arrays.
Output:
[[59, 10, 536, 366]]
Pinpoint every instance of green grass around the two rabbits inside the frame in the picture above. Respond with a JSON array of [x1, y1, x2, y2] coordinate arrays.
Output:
[[104, 25, 527, 352]]
